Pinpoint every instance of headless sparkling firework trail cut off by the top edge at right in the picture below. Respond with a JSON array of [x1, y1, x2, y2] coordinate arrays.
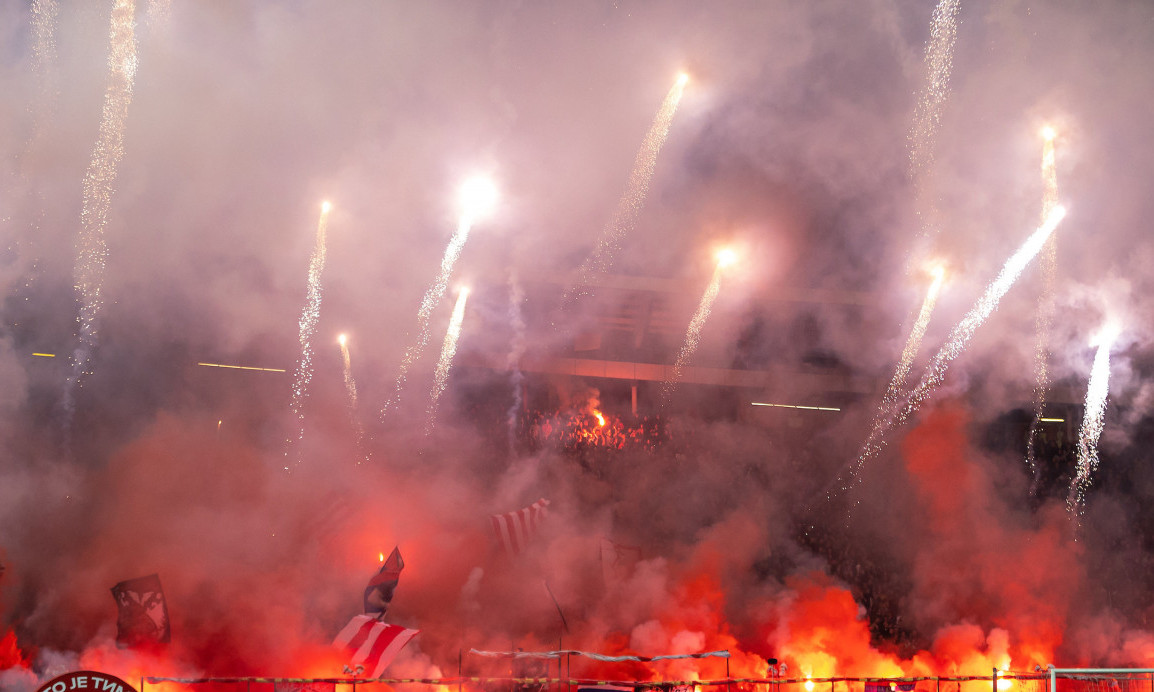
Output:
[[909, 0, 961, 238]]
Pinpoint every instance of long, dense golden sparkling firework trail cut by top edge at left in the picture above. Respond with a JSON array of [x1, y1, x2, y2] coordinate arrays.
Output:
[[63, 0, 136, 429]]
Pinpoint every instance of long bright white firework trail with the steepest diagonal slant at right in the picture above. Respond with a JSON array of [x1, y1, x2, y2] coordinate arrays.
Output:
[[826, 206, 1066, 499]]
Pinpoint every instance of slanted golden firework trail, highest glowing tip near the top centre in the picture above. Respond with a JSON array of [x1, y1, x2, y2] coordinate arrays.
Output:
[[564, 74, 689, 302]]
